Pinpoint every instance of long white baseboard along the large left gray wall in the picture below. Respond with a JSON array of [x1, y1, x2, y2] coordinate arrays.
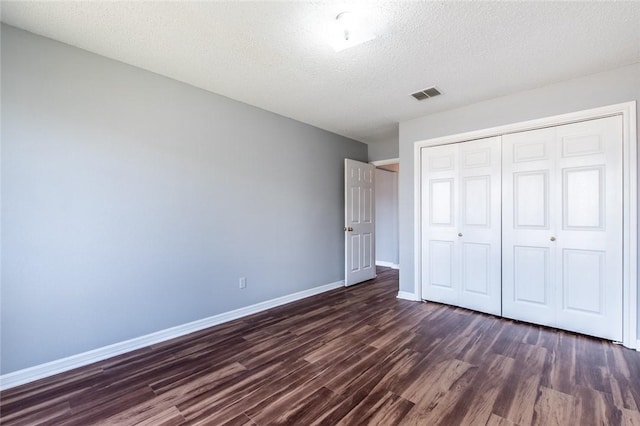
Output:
[[0, 281, 344, 390]]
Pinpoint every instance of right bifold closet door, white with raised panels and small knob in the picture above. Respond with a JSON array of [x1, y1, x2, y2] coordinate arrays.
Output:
[[502, 116, 622, 341]]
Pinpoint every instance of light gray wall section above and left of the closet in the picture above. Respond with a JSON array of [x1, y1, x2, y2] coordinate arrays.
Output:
[[400, 64, 640, 336]]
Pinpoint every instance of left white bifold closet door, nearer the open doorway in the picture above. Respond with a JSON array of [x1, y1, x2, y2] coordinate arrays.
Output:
[[421, 137, 501, 315]]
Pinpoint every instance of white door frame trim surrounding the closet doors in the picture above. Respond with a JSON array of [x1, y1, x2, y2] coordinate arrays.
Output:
[[412, 101, 640, 350]]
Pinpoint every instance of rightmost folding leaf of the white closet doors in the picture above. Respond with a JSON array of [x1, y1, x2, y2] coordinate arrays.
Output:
[[556, 116, 622, 341]]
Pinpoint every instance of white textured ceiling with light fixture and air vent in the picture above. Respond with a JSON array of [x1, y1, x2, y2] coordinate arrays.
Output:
[[2, 0, 640, 147]]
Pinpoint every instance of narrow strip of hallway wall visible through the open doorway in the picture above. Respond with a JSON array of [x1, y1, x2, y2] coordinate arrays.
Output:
[[375, 169, 398, 264]]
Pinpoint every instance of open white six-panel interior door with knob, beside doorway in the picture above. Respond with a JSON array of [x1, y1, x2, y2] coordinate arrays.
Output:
[[344, 159, 376, 286]]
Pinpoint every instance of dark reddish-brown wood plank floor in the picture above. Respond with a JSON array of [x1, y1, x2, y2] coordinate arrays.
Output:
[[0, 269, 640, 425]]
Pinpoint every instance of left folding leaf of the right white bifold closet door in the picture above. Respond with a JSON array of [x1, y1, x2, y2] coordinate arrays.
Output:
[[502, 129, 556, 325]]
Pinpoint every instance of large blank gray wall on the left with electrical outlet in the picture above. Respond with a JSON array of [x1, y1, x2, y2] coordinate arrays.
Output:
[[1, 25, 367, 373]]
